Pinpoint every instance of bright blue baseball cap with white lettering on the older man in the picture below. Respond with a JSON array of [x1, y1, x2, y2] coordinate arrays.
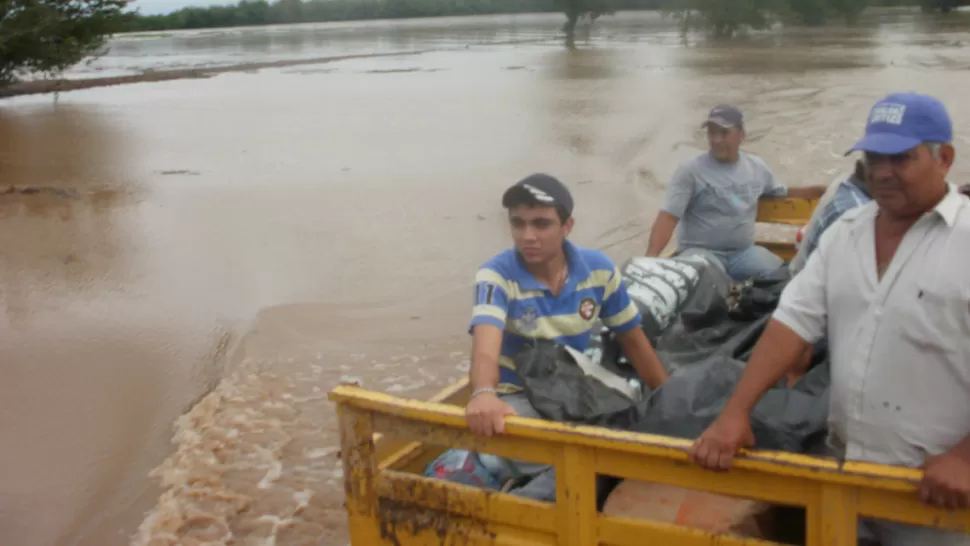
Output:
[[845, 93, 953, 155]]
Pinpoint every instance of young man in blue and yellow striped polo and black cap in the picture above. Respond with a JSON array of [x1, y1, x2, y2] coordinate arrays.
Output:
[[466, 174, 667, 436]]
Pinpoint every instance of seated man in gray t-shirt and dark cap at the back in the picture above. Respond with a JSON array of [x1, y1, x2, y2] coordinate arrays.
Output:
[[647, 105, 825, 281]]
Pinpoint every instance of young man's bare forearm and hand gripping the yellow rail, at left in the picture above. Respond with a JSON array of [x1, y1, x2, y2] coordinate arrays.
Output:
[[465, 324, 515, 436]]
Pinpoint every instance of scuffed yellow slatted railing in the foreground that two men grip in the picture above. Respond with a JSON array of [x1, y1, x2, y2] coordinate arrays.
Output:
[[330, 386, 970, 546]]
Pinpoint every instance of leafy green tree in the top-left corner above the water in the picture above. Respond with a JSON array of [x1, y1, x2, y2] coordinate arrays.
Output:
[[0, 0, 129, 85]]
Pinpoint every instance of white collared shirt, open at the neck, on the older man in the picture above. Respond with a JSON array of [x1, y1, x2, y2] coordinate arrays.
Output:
[[774, 184, 970, 467]]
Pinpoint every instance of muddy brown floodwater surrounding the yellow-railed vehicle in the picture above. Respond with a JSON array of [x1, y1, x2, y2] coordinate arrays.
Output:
[[0, 11, 970, 546]]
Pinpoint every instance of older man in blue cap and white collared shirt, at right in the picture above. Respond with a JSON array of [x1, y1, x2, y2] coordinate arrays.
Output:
[[691, 93, 970, 546]]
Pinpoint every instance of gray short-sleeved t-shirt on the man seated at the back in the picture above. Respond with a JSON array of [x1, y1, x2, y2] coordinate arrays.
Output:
[[663, 152, 788, 251]]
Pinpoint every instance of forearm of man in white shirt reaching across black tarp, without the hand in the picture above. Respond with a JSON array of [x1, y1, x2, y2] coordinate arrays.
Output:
[[724, 319, 810, 415]]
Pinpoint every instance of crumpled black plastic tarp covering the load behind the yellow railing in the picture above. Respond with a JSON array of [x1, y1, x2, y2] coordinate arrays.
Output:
[[515, 258, 829, 452]]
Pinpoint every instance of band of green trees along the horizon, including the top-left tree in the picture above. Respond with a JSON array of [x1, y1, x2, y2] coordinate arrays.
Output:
[[0, 0, 970, 87]]
